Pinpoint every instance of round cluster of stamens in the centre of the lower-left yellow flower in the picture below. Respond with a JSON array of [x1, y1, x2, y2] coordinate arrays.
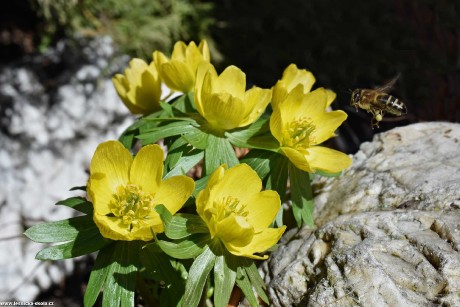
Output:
[[109, 184, 153, 231]]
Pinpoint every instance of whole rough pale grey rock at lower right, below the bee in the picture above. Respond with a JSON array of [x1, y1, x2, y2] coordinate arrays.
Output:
[[262, 123, 460, 306]]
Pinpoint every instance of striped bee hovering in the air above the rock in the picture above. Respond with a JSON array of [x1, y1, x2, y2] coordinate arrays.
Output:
[[350, 75, 407, 129]]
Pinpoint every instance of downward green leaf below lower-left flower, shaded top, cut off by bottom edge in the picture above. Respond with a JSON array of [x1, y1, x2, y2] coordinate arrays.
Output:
[[102, 241, 141, 307]]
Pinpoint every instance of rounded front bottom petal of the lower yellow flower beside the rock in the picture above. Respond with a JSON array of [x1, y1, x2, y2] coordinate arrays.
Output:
[[216, 214, 254, 246]]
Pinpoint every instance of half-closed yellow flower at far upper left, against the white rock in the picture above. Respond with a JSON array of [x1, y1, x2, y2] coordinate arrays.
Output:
[[112, 59, 161, 114]]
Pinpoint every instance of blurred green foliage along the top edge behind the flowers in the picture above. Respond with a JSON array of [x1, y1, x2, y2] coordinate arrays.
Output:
[[31, 0, 213, 58]]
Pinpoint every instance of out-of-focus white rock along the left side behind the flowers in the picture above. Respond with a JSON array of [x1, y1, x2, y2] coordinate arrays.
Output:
[[0, 38, 133, 301]]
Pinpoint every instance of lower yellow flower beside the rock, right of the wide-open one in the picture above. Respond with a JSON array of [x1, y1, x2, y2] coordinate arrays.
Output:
[[196, 164, 286, 259]]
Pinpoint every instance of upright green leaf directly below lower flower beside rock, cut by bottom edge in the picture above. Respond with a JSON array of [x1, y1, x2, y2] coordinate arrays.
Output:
[[214, 255, 236, 306]]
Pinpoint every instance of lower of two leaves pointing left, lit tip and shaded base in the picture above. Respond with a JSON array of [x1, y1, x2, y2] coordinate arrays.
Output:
[[35, 229, 113, 260]]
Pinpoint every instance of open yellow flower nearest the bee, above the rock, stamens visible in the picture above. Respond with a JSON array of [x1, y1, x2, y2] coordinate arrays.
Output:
[[270, 86, 351, 173]]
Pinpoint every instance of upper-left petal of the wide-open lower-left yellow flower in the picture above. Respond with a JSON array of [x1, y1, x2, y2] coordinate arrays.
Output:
[[90, 141, 132, 191]]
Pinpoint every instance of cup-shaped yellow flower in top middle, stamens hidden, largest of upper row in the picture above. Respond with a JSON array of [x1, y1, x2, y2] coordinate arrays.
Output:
[[195, 63, 271, 131]]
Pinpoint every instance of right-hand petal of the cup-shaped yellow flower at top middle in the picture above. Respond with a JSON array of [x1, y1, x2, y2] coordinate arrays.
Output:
[[238, 87, 271, 127]]
